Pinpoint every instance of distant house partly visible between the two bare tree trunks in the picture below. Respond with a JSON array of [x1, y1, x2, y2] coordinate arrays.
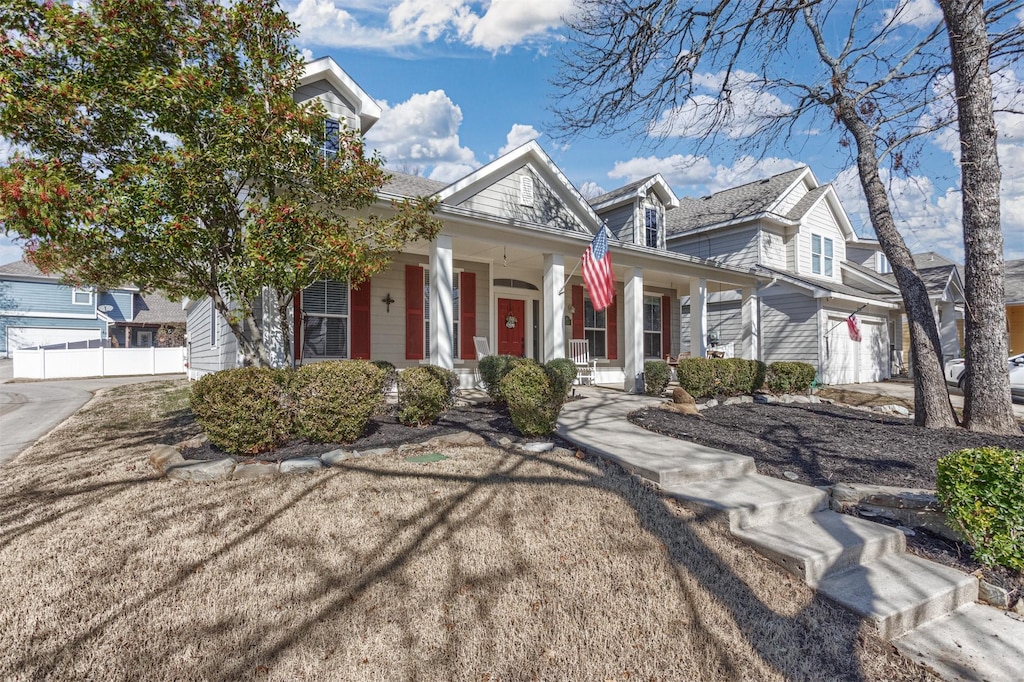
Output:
[[886, 251, 964, 364]]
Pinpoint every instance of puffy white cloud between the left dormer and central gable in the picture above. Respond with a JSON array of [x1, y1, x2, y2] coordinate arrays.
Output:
[[367, 90, 480, 179]]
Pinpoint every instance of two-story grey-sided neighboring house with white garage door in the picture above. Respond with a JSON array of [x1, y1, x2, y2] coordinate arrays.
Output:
[[666, 167, 900, 384]]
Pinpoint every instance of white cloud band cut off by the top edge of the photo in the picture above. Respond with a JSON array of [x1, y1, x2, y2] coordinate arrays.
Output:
[[290, 0, 573, 52]]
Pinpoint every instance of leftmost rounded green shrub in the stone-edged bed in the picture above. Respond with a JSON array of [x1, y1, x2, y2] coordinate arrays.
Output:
[[188, 367, 292, 455]]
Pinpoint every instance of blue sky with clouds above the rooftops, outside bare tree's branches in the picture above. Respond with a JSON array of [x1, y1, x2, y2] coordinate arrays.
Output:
[[0, 0, 1024, 262]]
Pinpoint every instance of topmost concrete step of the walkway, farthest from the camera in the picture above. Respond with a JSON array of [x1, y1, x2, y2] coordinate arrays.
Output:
[[663, 474, 828, 531]]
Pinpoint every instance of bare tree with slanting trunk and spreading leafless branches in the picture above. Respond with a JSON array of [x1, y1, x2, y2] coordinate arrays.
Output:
[[556, 0, 1017, 428]]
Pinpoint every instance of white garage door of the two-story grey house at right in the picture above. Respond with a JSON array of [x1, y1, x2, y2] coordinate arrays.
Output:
[[822, 316, 889, 385]]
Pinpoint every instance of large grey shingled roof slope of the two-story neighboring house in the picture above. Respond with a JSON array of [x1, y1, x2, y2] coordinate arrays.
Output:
[[666, 166, 810, 237]]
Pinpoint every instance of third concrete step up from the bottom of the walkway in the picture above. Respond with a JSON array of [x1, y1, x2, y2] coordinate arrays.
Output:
[[733, 509, 906, 587]]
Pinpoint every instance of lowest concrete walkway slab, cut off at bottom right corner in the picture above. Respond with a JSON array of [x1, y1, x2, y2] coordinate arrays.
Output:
[[893, 604, 1024, 682]]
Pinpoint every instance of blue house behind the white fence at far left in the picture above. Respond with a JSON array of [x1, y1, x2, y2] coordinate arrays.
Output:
[[0, 260, 185, 356]]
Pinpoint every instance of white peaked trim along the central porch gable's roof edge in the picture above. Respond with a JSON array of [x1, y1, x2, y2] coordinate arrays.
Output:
[[437, 140, 602, 232]]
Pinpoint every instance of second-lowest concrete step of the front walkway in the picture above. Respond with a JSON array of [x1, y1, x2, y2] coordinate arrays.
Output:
[[817, 554, 978, 639]]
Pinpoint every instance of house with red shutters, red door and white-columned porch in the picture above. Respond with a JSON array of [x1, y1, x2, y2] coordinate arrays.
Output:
[[187, 58, 765, 389]]
